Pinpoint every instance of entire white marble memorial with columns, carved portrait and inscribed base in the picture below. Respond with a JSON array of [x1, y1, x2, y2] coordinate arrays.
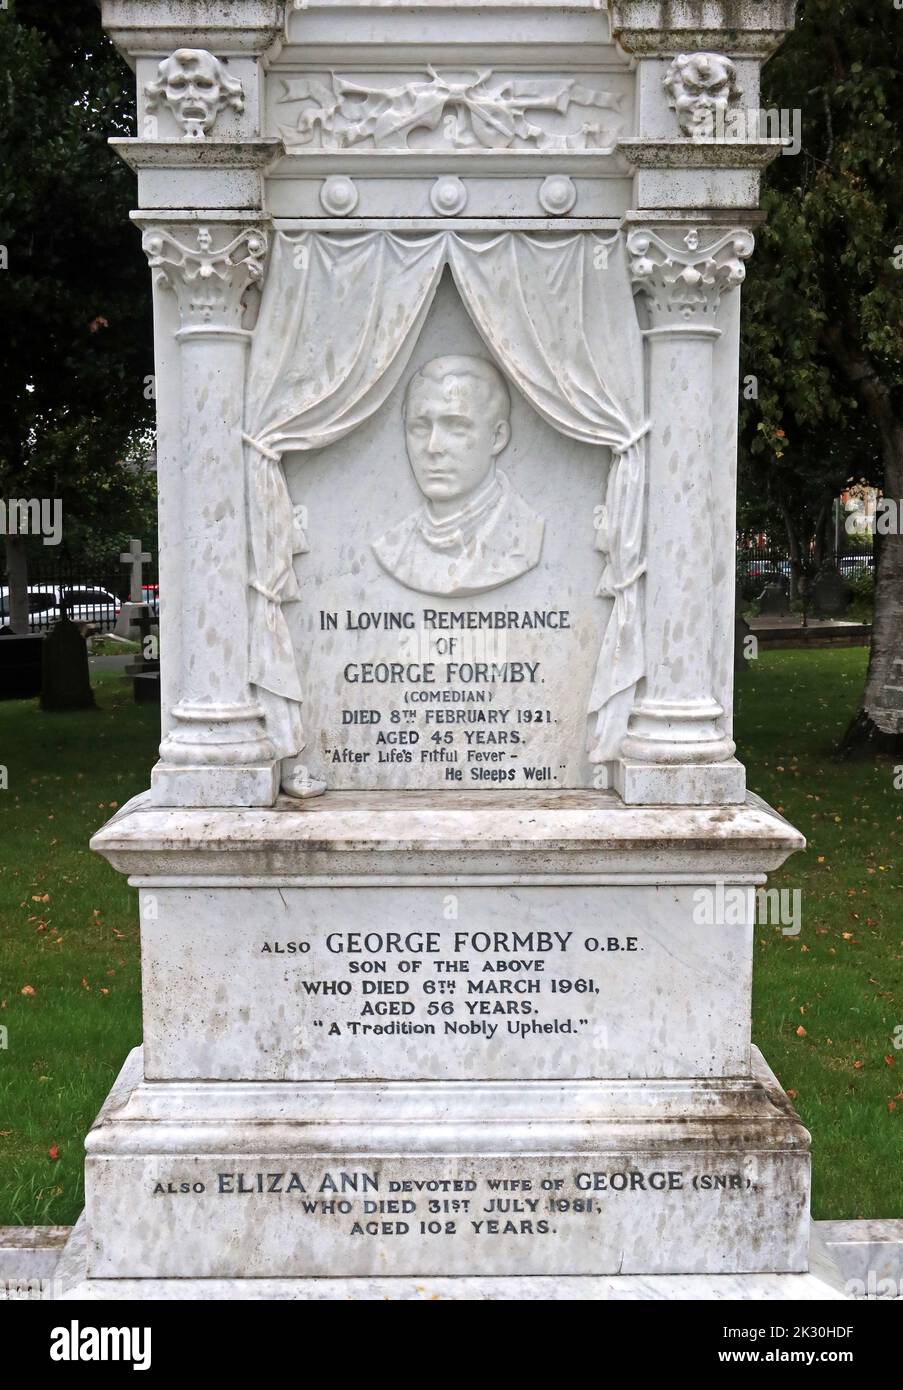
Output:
[[63, 0, 844, 1297]]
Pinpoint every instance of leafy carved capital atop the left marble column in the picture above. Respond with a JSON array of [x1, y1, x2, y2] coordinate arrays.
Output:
[[142, 227, 267, 329]]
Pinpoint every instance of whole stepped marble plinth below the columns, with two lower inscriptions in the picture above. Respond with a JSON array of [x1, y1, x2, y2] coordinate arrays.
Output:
[[86, 792, 809, 1279]]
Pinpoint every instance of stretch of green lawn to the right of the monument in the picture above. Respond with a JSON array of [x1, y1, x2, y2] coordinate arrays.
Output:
[[736, 648, 903, 1218]]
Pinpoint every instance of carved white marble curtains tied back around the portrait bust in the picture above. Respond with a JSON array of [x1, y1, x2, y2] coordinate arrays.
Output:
[[245, 231, 646, 762]]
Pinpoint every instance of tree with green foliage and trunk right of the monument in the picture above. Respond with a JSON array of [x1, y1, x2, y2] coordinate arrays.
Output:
[[740, 0, 903, 733]]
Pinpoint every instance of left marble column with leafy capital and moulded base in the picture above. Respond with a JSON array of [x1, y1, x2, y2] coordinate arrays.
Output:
[[143, 225, 278, 806]]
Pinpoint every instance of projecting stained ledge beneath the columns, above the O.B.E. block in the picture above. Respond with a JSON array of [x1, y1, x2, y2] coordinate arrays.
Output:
[[92, 790, 804, 883]]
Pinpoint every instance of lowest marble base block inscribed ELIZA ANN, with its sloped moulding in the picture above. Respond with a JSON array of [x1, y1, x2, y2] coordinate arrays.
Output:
[[80, 1052, 809, 1279]]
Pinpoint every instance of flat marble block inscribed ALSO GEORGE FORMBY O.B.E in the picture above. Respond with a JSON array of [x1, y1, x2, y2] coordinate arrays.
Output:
[[135, 876, 754, 1080]]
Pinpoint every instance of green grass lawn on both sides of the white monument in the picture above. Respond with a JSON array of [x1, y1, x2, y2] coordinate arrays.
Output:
[[0, 648, 903, 1225]]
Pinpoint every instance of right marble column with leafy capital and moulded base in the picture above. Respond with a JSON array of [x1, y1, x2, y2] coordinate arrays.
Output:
[[615, 227, 753, 805]]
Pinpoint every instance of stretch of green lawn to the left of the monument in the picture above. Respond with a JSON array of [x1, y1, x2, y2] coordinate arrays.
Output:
[[0, 671, 152, 1225]]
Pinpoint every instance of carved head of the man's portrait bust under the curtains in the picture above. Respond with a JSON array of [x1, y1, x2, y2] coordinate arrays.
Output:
[[404, 357, 511, 502]]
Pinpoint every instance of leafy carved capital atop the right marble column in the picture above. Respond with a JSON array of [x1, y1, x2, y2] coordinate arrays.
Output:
[[627, 228, 756, 328]]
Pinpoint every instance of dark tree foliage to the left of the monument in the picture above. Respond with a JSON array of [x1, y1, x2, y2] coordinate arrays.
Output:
[[0, 0, 154, 592]]
